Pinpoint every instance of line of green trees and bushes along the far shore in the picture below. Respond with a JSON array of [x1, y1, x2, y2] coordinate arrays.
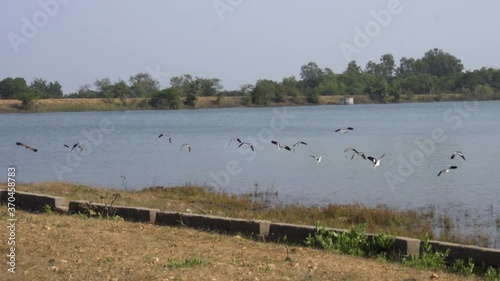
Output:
[[0, 48, 500, 108]]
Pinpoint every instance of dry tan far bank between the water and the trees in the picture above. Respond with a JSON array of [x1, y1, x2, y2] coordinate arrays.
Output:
[[0, 94, 464, 113]]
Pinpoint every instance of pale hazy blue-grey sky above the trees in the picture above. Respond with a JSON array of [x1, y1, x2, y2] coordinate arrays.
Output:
[[0, 0, 500, 94]]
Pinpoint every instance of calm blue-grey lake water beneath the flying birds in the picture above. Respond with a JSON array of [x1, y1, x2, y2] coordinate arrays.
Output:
[[0, 101, 500, 247]]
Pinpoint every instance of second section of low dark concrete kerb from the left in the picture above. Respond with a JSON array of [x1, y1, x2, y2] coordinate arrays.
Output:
[[68, 200, 160, 223]]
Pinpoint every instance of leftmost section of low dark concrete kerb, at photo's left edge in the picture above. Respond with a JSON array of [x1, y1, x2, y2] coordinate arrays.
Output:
[[0, 190, 66, 212]]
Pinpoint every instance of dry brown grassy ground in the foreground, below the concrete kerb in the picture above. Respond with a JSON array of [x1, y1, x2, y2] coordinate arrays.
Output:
[[0, 210, 479, 281]]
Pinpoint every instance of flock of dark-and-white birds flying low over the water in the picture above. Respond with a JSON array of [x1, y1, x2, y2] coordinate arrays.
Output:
[[16, 127, 465, 177]]
